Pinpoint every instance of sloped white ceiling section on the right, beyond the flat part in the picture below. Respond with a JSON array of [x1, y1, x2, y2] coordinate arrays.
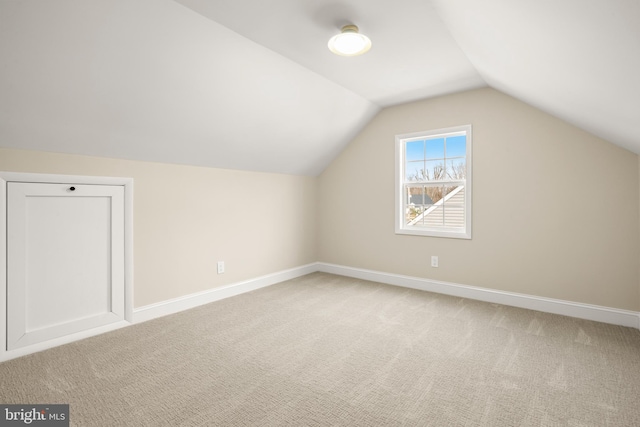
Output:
[[432, 0, 640, 154]]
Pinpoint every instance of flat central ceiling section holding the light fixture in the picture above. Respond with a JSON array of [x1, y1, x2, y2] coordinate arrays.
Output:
[[176, 0, 486, 107]]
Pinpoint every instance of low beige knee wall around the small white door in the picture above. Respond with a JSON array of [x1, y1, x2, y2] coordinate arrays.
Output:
[[0, 149, 317, 307]]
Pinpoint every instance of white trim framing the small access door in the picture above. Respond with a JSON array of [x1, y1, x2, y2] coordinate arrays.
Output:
[[0, 171, 133, 361]]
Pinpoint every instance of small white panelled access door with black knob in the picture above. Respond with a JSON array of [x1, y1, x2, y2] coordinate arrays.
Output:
[[6, 182, 125, 350]]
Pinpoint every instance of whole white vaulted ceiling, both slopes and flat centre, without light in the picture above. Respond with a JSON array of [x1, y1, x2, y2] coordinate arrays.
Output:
[[0, 0, 640, 175]]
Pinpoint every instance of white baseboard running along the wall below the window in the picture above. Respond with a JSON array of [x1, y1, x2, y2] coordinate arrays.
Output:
[[317, 262, 640, 329]]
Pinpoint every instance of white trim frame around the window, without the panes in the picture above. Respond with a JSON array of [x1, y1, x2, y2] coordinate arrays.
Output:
[[395, 125, 473, 239]]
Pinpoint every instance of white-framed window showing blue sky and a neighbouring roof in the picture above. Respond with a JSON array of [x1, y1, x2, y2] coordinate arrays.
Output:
[[396, 125, 471, 239]]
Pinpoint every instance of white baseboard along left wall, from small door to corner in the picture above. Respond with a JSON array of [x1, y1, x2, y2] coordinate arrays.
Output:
[[133, 263, 318, 323]]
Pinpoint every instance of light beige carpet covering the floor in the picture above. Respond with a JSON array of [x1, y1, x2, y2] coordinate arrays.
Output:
[[0, 273, 640, 426]]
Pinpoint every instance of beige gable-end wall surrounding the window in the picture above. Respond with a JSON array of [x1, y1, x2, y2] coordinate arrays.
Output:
[[318, 89, 640, 310]]
